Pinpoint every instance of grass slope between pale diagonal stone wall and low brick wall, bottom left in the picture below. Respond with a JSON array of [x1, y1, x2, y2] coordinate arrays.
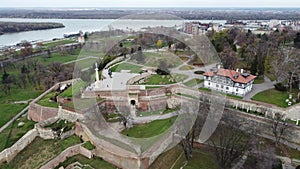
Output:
[[0, 136, 81, 169]]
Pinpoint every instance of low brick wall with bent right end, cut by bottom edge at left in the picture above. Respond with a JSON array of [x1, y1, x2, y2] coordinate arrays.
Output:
[[40, 144, 93, 169]]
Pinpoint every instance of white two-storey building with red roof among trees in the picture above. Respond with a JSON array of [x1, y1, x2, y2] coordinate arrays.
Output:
[[203, 68, 256, 96]]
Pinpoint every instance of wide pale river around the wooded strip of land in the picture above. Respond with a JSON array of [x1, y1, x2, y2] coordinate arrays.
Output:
[[0, 18, 225, 48]]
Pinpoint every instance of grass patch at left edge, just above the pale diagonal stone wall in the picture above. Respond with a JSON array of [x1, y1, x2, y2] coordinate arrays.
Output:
[[0, 115, 35, 152]]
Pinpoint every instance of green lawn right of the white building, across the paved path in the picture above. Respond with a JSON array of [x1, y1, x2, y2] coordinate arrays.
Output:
[[251, 89, 296, 107]]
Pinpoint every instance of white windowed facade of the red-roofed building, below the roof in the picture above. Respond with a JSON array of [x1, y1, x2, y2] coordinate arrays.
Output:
[[204, 75, 254, 96]]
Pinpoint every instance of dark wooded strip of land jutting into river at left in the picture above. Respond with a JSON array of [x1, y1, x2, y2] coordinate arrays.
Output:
[[0, 22, 65, 35]]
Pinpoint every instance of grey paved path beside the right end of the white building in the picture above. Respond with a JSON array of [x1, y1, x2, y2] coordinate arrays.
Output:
[[243, 76, 276, 100]]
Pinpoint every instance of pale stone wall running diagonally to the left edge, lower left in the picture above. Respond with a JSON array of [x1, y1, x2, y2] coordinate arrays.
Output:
[[0, 129, 38, 163]]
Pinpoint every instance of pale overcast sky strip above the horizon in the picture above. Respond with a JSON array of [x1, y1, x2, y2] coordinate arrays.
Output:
[[0, 0, 300, 8]]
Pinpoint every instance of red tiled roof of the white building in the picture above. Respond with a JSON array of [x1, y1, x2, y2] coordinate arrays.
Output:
[[203, 68, 256, 83]]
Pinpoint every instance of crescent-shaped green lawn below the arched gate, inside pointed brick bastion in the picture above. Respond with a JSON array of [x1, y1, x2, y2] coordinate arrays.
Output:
[[122, 116, 177, 138]]
